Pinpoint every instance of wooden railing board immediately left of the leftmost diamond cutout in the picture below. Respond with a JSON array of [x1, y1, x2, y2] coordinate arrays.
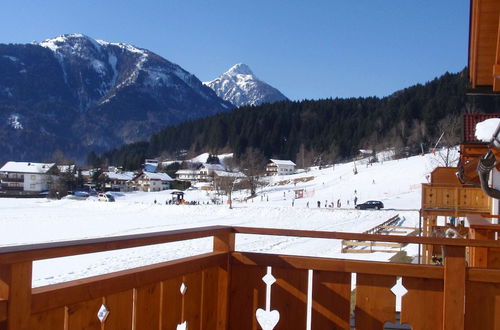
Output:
[[68, 298, 102, 330]]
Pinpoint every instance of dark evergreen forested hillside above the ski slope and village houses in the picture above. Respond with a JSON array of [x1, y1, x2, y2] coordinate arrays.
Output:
[[94, 70, 498, 168]]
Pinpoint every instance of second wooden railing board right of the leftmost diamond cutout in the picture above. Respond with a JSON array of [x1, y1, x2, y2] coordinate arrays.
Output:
[[135, 283, 161, 330]]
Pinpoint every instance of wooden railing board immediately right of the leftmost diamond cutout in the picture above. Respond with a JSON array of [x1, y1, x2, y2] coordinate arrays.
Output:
[[104, 290, 134, 330]]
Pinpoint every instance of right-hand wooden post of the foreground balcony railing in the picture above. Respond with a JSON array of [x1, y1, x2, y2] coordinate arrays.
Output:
[[443, 246, 465, 330]]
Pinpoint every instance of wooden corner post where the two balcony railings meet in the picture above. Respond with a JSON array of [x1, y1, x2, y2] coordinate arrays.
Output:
[[214, 230, 235, 330]]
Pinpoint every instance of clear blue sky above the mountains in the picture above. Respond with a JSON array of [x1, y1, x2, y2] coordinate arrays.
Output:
[[0, 0, 469, 100]]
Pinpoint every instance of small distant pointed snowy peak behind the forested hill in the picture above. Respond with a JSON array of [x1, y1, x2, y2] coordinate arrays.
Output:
[[204, 63, 288, 107]]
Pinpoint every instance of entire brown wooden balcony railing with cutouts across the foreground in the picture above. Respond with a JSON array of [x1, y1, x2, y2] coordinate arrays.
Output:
[[0, 226, 500, 330]]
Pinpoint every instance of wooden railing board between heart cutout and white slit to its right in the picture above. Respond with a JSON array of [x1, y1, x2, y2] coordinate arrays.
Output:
[[271, 267, 308, 330]]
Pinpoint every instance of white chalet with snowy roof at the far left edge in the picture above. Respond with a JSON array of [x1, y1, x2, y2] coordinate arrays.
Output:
[[0, 162, 59, 195]]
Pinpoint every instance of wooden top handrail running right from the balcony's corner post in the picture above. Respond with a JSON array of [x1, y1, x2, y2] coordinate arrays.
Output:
[[233, 227, 500, 248]]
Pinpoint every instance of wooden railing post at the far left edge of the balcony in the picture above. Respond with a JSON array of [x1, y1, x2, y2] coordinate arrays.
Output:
[[0, 261, 32, 330]]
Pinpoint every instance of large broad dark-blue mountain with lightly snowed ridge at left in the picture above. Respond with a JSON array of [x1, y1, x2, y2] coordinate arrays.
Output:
[[0, 34, 233, 161]]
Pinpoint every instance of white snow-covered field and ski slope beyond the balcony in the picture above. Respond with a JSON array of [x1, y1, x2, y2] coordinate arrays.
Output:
[[0, 155, 436, 286]]
